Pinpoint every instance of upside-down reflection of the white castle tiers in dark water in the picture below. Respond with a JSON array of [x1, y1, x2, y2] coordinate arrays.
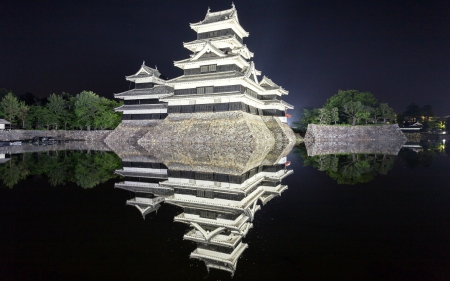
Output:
[[115, 149, 292, 275]]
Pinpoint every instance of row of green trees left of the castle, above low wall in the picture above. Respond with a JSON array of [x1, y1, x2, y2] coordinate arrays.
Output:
[[0, 89, 122, 130]]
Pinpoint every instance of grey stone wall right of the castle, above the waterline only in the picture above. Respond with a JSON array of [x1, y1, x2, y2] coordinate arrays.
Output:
[[305, 124, 406, 143]]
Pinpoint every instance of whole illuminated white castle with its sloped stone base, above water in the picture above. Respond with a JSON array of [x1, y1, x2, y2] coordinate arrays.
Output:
[[107, 5, 295, 146]]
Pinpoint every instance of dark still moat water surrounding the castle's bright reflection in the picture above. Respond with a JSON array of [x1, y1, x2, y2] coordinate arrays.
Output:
[[0, 142, 450, 280]]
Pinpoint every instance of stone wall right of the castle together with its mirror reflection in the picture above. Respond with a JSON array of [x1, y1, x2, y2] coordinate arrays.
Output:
[[304, 124, 407, 156]]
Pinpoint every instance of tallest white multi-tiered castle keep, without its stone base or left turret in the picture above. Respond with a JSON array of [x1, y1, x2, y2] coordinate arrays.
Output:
[[161, 5, 293, 122]]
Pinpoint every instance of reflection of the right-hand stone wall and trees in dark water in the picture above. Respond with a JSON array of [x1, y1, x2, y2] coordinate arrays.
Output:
[[294, 140, 450, 185]]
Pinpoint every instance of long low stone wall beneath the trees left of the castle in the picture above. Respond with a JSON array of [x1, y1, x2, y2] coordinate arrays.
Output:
[[0, 130, 113, 142]]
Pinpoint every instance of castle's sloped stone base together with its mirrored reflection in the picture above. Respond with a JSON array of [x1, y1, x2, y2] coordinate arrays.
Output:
[[105, 112, 295, 173]]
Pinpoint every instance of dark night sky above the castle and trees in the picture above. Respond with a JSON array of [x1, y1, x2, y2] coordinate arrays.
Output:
[[0, 0, 450, 115]]
